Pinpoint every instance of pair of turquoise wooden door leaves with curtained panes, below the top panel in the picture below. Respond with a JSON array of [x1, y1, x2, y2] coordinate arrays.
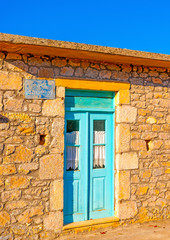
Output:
[[64, 112, 114, 224]]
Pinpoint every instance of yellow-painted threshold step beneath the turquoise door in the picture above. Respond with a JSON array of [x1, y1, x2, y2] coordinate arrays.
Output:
[[63, 217, 119, 230]]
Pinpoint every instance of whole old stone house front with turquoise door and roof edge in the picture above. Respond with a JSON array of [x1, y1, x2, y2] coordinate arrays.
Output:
[[0, 34, 170, 240]]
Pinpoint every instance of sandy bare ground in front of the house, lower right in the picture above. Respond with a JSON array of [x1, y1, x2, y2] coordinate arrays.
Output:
[[58, 220, 170, 240]]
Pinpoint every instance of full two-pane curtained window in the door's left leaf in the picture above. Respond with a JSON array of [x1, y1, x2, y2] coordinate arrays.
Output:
[[66, 120, 79, 171]]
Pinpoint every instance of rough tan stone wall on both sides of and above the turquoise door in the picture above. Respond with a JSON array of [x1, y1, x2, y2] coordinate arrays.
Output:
[[0, 53, 170, 240]]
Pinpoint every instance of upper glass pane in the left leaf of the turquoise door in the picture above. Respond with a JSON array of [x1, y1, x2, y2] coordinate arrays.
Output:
[[66, 120, 79, 144]]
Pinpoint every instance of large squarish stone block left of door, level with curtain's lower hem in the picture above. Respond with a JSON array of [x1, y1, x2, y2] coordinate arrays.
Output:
[[39, 154, 63, 179]]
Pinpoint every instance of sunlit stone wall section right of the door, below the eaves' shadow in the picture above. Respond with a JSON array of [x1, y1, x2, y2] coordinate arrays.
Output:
[[115, 85, 170, 222]]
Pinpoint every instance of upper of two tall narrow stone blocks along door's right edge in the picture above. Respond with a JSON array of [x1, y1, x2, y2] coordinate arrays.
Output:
[[116, 124, 130, 153]]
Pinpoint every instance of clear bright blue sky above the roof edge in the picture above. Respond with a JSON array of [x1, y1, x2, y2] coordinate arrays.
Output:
[[0, 0, 170, 54]]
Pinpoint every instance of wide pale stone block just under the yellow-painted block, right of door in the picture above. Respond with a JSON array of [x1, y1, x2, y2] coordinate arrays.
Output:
[[116, 105, 137, 123]]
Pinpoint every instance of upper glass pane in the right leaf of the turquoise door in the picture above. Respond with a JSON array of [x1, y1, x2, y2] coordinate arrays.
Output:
[[93, 120, 105, 144]]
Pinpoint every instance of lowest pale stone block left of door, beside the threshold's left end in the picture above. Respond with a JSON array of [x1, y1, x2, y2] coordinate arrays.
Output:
[[44, 211, 63, 231]]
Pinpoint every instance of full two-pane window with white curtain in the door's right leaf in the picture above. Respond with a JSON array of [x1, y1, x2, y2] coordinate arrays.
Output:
[[93, 120, 105, 168]]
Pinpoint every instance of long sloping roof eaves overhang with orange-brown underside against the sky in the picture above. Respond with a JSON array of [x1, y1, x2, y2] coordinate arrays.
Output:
[[0, 33, 170, 68]]
